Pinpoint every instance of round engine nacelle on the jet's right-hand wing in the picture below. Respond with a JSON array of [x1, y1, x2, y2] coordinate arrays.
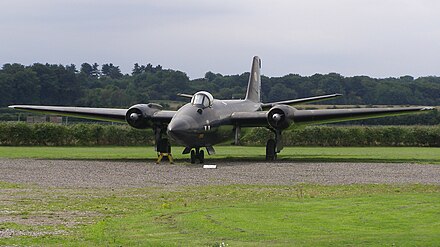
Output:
[[267, 105, 296, 130]]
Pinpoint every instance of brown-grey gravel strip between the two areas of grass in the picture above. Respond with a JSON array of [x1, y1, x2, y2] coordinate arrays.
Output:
[[0, 159, 440, 188]]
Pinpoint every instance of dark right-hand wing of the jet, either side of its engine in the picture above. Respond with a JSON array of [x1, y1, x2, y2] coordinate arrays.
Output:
[[231, 107, 434, 127]]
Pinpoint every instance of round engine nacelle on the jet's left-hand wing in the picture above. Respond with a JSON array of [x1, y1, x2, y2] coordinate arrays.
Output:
[[125, 103, 162, 129]]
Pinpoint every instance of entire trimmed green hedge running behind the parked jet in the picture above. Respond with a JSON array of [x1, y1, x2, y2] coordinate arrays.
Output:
[[0, 122, 440, 147]]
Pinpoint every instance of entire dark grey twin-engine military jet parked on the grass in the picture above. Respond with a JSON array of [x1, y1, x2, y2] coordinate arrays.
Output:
[[9, 56, 433, 163]]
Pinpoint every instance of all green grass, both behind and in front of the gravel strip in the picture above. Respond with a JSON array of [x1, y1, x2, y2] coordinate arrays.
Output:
[[0, 146, 440, 246]]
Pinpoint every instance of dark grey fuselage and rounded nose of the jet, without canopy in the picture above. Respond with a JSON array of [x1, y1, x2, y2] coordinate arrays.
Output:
[[167, 99, 261, 148]]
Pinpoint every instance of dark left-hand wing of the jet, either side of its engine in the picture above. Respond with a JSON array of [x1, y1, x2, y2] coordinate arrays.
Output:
[[9, 105, 176, 123]]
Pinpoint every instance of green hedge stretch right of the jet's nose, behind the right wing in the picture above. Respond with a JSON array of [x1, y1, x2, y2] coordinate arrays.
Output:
[[241, 125, 440, 147]]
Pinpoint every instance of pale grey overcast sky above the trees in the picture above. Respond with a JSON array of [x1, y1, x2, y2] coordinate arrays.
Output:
[[0, 0, 440, 78]]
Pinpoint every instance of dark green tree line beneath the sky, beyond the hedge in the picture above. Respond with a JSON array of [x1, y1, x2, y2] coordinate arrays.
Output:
[[0, 63, 440, 107]]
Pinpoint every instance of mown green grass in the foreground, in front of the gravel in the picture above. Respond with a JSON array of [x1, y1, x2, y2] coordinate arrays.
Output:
[[0, 184, 440, 246]]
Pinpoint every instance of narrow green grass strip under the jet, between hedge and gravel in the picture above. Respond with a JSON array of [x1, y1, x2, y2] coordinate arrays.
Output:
[[0, 146, 440, 164]]
